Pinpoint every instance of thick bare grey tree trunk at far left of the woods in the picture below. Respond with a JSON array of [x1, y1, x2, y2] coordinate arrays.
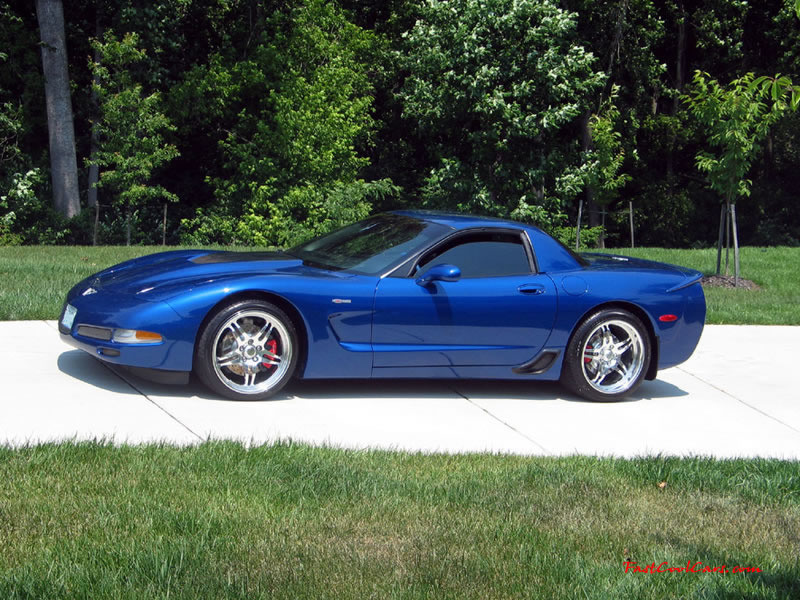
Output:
[[36, 0, 81, 218]]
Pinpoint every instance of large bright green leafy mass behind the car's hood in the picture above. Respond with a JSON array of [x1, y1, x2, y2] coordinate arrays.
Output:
[[173, 0, 382, 245]]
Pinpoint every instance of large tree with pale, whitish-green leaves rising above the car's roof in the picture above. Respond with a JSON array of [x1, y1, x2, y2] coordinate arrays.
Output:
[[402, 0, 604, 226]]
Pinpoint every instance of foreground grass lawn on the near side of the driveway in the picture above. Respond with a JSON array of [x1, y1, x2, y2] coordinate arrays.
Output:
[[0, 443, 800, 600]]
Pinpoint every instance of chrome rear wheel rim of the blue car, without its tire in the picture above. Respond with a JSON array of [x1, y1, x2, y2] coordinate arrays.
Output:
[[581, 319, 646, 394]]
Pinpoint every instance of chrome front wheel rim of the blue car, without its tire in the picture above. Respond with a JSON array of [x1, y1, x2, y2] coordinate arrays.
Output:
[[211, 309, 295, 395]]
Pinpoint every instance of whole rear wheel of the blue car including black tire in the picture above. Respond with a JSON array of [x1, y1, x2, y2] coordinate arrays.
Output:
[[561, 309, 651, 402]]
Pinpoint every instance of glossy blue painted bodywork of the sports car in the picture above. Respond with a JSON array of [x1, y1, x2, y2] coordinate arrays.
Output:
[[61, 211, 705, 390]]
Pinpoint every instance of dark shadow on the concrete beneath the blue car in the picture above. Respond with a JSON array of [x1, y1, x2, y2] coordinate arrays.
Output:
[[58, 350, 687, 402]]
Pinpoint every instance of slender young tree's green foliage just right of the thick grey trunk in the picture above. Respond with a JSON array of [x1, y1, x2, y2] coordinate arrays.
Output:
[[89, 31, 178, 217]]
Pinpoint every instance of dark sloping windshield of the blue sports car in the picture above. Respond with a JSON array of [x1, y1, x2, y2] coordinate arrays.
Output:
[[286, 214, 449, 275]]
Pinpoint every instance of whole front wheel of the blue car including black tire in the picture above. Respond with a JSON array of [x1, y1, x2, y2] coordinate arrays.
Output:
[[195, 300, 299, 400]]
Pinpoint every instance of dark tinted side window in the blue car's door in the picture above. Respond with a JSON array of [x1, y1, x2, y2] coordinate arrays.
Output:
[[413, 233, 531, 277]]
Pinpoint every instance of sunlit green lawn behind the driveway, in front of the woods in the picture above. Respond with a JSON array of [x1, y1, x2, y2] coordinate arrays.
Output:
[[0, 246, 800, 325]]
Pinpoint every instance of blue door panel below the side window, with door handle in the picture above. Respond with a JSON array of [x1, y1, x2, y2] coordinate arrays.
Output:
[[372, 273, 557, 368]]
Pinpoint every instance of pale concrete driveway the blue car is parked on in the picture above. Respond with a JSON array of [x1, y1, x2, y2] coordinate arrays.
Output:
[[0, 321, 800, 460]]
